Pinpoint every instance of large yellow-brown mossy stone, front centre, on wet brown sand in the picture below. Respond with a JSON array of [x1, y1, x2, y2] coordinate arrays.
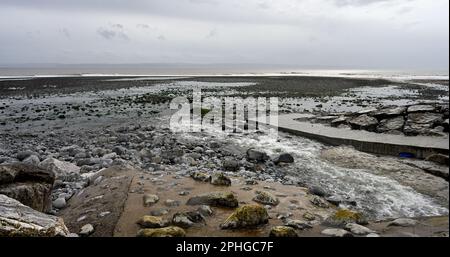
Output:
[[220, 205, 269, 229]]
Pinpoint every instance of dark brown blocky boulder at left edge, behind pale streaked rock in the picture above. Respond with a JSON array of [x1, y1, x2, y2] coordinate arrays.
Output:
[[0, 163, 55, 212]]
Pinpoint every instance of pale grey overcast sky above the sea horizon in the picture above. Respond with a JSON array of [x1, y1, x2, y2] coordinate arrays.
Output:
[[0, 0, 449, 69]]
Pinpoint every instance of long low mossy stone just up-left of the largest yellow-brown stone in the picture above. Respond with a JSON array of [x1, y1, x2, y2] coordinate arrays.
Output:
[[186, 192, 239, 208]]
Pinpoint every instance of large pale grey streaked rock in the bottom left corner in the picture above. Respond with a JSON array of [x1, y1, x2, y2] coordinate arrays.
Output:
[[0, 194, 69, 237]]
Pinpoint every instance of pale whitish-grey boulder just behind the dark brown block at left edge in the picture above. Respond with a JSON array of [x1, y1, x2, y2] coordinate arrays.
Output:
[[39, 158, 80, 181]]
